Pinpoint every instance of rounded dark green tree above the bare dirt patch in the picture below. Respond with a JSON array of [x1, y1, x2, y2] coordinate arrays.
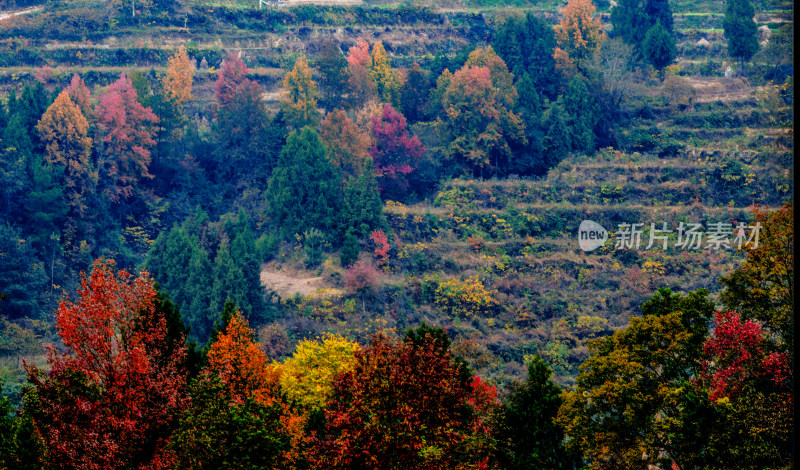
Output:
[[267, 128, 341, 238]]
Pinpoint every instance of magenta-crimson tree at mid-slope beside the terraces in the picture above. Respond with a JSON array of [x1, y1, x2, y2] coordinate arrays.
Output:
[[369, 103, 425, 194]]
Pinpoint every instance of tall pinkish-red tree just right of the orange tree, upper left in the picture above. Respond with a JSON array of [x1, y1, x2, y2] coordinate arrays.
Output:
[[97, 73, 158, 201]]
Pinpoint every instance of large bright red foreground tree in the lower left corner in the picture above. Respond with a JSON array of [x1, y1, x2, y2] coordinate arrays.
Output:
[[26, 261, 186, 469]]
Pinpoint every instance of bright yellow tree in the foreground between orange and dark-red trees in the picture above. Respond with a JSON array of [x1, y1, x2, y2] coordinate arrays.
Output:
[[281, 334, 359, 408]]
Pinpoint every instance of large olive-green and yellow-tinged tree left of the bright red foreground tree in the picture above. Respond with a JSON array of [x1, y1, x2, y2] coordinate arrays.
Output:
[[558, 289, 714, 468]]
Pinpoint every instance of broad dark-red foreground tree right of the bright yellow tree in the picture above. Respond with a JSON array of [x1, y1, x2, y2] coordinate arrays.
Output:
[[310, 336, 492, 470]]
